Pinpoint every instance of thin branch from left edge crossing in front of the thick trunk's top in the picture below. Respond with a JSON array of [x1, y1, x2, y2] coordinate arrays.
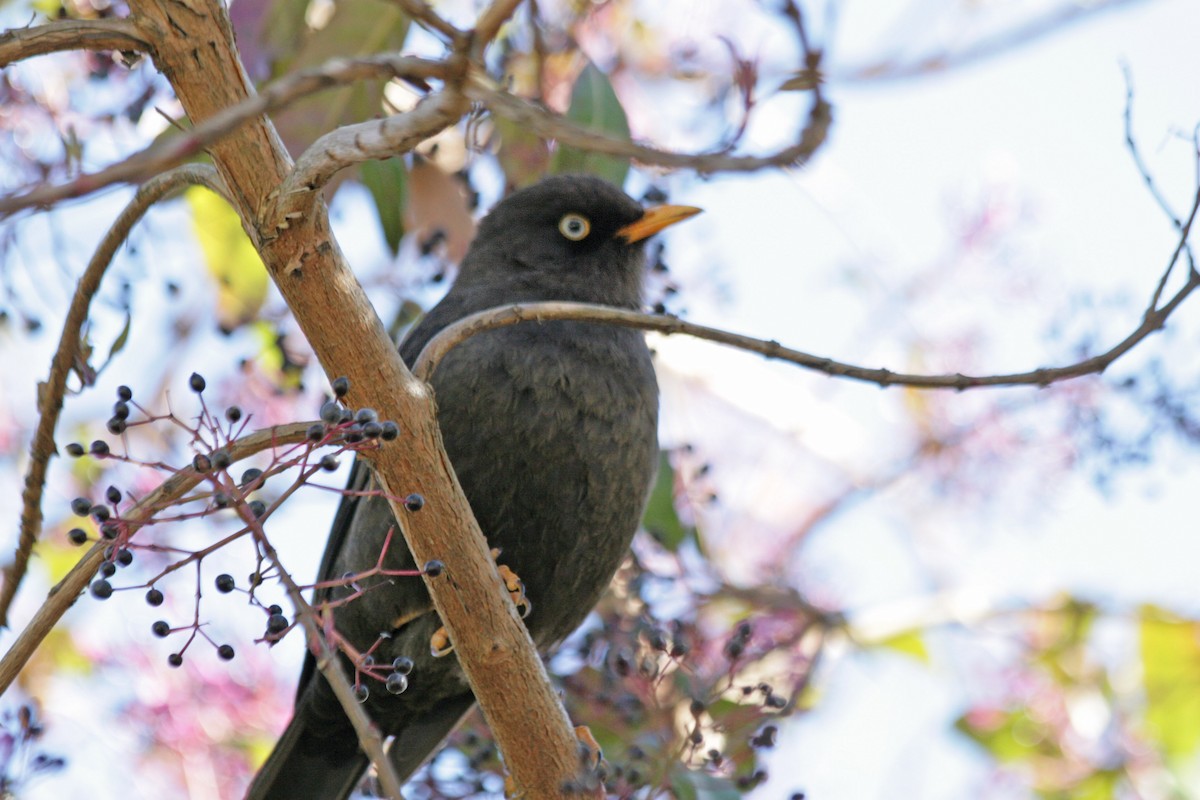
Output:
[[0, 54, 445, 217]]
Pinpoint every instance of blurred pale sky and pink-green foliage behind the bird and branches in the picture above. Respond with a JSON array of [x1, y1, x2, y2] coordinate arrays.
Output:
[[0, 0, 1200, 800]]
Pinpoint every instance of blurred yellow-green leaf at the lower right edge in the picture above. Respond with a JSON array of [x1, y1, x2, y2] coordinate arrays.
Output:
[[1139, 606, 1200, 760]]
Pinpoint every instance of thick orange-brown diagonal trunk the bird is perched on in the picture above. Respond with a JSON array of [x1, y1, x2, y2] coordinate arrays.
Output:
[[119, 0, 588, 800]]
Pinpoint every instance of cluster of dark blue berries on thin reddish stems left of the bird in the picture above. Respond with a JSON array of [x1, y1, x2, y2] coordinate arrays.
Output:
[[65, 373, 432, 693]]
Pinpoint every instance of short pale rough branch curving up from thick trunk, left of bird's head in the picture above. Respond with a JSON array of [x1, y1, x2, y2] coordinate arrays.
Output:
[[273, 92, 467, 230]]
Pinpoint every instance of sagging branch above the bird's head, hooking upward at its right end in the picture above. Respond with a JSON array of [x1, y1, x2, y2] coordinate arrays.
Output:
[[464, 71, 832, 174]]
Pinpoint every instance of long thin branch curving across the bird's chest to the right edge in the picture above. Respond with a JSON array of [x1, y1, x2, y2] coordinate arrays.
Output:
[[413, 184, 1200, 391]]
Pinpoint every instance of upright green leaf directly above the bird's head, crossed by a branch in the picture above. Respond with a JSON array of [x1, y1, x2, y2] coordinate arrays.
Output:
[[550, 61, 629, 186]]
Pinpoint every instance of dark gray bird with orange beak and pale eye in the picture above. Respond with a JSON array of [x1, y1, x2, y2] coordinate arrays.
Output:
[[247, 175, 698, 800]]
